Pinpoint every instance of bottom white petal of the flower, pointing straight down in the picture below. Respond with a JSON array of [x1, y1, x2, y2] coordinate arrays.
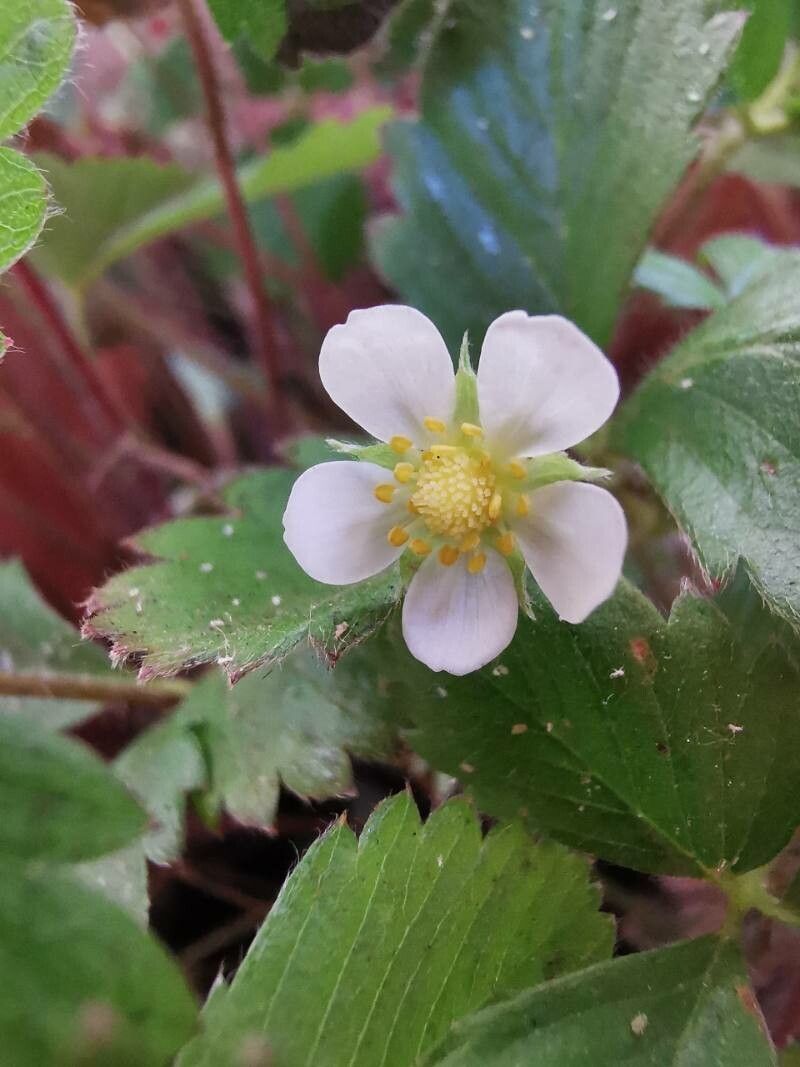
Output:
[[403, 551, 518, 674]]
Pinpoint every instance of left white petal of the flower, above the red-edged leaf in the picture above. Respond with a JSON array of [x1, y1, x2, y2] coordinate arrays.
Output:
[[284, 460, 405, 586]]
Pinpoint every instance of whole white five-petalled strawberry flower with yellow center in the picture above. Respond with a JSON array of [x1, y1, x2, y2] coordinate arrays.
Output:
[[284, 305, 627, 674]]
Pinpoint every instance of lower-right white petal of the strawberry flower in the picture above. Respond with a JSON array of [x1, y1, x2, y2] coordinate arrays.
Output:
[[514, 481, 628, 622]]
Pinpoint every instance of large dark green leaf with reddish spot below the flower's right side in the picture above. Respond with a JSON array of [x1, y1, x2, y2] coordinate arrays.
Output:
[[335, 583, 800, 875]]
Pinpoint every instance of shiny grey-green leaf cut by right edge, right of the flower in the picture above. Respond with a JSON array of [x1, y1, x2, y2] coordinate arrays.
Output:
[[615, 252, 800, 620]]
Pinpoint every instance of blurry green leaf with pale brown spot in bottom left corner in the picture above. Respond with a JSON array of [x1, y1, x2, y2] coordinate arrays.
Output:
[[0, 864, 196, 1067]]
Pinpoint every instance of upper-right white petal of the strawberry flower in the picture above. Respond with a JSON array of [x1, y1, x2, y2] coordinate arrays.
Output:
[[478, 312, 620, 456]]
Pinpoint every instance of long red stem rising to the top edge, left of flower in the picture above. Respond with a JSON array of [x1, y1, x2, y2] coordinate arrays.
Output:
[[179, 0, 282, 410]]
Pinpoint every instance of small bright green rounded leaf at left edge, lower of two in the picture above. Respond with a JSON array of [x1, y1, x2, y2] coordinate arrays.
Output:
[[0, 150, 47, 273]]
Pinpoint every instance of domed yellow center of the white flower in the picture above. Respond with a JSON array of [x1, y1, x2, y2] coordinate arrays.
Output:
[[411, 445, 499, 539]]
